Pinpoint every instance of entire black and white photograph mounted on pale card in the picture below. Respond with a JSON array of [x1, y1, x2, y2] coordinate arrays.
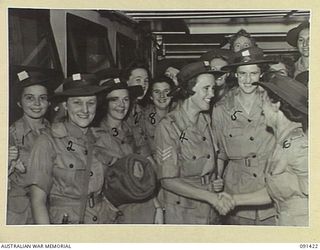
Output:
[[3, 0, 317, 242]]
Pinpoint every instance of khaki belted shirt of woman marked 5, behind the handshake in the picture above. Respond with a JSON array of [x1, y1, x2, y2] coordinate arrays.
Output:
[[212, 88, 275, 219]]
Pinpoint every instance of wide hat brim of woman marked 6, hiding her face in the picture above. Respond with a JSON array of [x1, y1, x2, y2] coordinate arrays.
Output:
[[256, 75, 308, 115]]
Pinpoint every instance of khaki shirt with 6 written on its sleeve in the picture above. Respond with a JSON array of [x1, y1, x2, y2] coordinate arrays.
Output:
[[266, 123, 309, 225]]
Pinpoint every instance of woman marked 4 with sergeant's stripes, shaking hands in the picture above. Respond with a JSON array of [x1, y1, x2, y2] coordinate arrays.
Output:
[[155, 61, 231, 224]]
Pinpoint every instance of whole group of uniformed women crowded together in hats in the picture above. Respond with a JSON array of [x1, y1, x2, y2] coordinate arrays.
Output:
[[7, 23, 309, 226]]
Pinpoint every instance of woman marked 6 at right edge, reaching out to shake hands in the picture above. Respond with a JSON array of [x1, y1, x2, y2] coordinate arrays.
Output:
[[226, 74, 309, 226]]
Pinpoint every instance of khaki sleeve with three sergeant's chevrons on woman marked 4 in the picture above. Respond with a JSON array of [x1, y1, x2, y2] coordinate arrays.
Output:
[[155, 119, 180, 179]]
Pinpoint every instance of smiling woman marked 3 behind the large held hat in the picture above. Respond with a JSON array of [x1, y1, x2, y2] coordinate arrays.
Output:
[[100, 78, 162, 224]]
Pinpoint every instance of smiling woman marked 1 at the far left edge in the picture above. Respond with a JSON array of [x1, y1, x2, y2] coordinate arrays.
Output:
[[7, 71, 50, 225]]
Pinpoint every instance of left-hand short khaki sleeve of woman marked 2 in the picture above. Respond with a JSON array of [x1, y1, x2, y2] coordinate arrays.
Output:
[[29, 135, 55, 194]]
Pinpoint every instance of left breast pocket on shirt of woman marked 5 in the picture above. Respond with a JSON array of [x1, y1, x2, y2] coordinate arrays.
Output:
[[223, 128, 242, 156]]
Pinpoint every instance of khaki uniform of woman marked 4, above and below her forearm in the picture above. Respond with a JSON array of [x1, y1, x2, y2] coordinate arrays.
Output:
[[155, 106, 216, 224]]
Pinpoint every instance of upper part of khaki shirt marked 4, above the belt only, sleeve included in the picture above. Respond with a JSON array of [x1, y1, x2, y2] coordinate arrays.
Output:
[[155, 107, 216, 178]]
